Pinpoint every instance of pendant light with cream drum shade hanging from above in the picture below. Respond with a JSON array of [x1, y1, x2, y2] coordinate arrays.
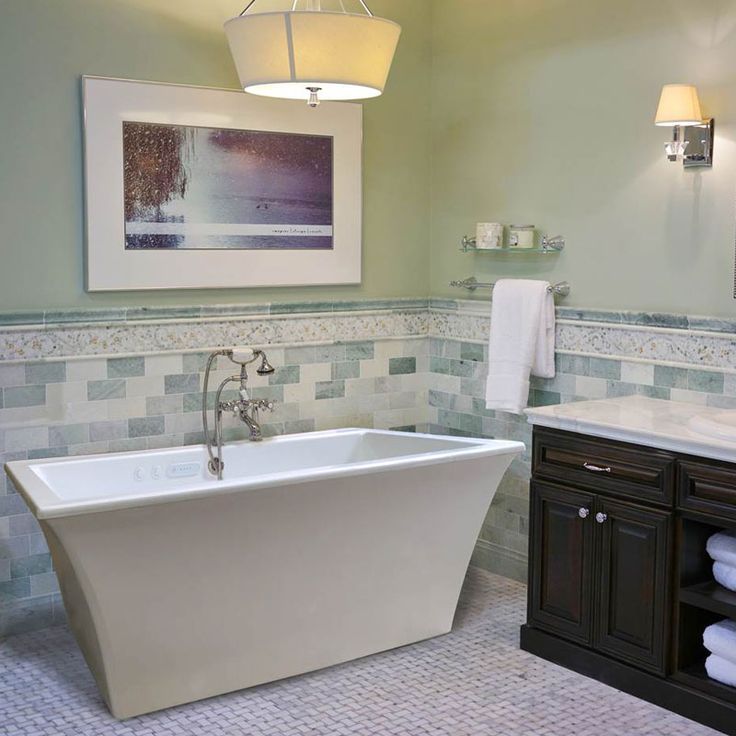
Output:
[[225, 0, 401, 107]]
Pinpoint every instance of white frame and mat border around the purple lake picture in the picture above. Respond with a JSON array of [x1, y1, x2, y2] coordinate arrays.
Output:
[[82, 76, 362, 292]]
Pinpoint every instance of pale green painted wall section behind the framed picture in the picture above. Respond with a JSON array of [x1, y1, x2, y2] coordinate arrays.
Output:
[[0, 0, 430, 311]]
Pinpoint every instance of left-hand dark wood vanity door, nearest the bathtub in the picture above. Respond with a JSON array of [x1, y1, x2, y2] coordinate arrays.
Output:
[[529, 482, 595, 645]]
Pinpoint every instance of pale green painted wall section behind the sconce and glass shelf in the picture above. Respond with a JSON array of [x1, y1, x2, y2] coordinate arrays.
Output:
[[431, 0, 736, 315]]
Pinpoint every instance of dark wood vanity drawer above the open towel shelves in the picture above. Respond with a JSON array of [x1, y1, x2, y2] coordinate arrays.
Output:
[[677, 460, 736, 519]]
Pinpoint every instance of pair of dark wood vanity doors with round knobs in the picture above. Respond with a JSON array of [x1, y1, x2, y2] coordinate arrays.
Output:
[[529, 481, 671, 672]]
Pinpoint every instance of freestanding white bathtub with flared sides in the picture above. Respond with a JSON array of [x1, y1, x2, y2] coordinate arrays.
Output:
[[6, 429, 523, 718]]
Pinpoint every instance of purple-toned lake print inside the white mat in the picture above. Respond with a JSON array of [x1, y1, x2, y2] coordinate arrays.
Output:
[[123, 121, 333, 249]]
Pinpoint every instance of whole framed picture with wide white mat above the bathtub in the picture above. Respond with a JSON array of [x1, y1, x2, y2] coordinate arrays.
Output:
[[82, 77, 362, 291]]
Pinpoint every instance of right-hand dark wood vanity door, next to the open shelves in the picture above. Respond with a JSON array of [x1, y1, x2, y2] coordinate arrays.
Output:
[[594, 498, 671, 674]]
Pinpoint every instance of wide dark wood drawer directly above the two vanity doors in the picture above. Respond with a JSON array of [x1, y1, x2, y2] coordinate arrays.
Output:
[[533, 429, 675, 506]]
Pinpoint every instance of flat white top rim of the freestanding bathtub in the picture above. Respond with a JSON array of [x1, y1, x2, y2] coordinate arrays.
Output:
[[5, 427, 526, 520]]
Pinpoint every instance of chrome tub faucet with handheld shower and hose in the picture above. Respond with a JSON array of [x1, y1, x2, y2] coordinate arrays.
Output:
[[202, 348, 276, 480]]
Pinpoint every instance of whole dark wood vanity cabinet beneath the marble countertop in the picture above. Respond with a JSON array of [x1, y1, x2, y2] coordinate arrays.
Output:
[[521, 427, 736, 736]]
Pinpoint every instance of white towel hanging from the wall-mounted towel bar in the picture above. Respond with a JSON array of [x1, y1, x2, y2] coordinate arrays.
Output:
[[486, 279, 555, 414]]
